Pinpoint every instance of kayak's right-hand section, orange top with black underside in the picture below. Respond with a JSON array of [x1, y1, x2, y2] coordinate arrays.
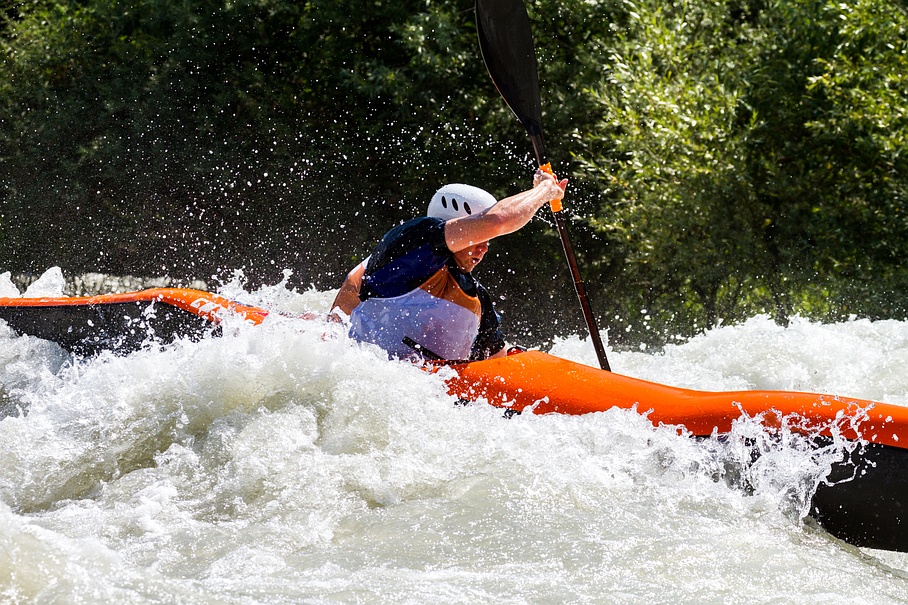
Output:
[[448, 352, 908, 552]]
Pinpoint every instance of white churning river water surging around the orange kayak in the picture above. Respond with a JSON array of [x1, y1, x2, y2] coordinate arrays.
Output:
[[0, 272, 908, 605]]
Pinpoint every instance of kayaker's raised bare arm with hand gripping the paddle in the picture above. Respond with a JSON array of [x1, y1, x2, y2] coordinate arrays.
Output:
[[445, 170, 567, 252]]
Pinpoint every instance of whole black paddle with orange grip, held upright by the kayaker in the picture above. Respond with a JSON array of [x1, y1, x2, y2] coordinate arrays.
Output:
[[476, 0, 611, 371]]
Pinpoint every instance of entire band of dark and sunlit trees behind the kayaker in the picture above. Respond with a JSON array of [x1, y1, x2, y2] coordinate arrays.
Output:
[[0, 0, 908, 344]]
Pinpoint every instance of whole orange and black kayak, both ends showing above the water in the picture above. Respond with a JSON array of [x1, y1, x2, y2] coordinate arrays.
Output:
[[0, 288, 908, 552]]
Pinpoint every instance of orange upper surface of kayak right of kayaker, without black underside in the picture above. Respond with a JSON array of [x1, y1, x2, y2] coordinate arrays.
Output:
[[448, 351, 908, 448]]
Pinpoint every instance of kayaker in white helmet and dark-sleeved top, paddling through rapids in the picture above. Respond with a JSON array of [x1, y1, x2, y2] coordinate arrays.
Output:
[[332, 171, 567, 359]]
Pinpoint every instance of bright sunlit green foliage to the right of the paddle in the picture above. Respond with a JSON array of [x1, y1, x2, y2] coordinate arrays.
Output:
[[583, 0, 908, 340]]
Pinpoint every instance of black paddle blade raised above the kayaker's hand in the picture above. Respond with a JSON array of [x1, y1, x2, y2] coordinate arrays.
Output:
[[476, 0, 548, 166]]
